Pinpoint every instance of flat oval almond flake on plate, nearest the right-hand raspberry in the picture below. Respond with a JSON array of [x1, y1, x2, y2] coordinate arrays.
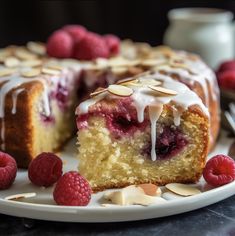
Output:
[[165, 183, 201, 197]]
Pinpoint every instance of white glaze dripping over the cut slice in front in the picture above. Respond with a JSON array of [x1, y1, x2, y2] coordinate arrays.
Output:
[[76, 72, 209, 161]]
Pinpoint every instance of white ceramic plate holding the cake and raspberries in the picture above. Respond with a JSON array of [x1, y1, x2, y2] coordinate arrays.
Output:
[[0, 132, 235, 222]]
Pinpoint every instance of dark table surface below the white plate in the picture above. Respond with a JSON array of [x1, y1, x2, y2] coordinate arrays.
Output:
[[0, 196, 235, 236]]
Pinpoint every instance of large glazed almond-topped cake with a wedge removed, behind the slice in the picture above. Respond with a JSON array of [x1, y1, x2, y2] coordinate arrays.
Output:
[[0, 41, 219, 167]]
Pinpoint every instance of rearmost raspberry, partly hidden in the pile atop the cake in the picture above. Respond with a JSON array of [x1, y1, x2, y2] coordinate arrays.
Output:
[[62, 25, 87, 43]]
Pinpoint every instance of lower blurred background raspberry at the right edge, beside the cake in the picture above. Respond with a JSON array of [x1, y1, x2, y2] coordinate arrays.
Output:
[[217, 70, 235, 90]]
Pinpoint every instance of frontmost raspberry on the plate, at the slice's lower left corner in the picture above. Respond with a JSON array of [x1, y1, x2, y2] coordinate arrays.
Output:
[[53, 171, 92, 206]]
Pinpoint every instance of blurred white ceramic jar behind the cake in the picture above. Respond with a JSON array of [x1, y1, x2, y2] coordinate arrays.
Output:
[[164, 8, 234, 69]]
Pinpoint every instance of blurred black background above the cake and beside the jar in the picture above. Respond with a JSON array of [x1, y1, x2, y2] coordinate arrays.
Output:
[[0, 0, 235, 47]]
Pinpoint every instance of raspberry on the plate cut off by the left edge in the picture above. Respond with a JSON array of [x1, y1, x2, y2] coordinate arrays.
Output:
[[0, 152, 17, 189]]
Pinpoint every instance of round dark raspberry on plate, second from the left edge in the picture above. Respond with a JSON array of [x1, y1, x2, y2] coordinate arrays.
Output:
[[28, 152, 63, 187]]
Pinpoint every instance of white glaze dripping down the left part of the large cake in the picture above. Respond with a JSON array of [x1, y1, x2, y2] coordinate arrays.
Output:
[[0, 56, 84, 150]]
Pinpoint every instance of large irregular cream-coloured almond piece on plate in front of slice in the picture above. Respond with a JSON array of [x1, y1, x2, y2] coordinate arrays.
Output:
[[104, 185, 166, 206]]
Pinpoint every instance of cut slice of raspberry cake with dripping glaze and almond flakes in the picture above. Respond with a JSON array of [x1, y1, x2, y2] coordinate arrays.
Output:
[[76, 72, 209, 191]]
